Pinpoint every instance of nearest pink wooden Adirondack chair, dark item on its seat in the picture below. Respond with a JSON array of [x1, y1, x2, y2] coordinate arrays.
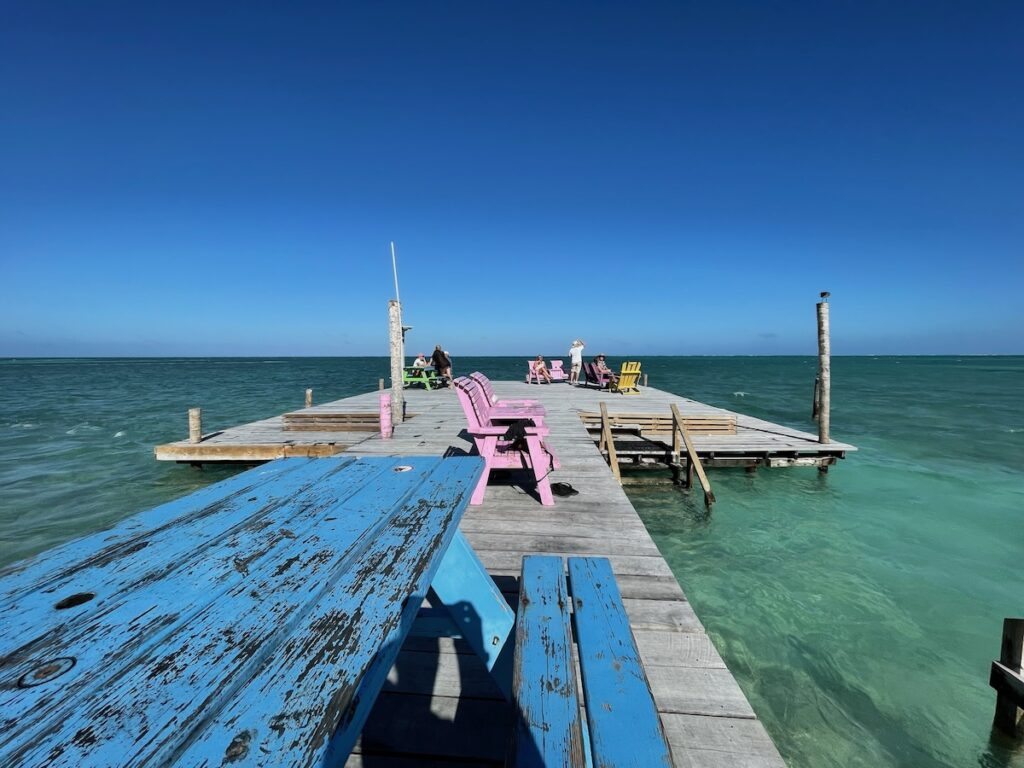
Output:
[[454, 377, 560, 507]]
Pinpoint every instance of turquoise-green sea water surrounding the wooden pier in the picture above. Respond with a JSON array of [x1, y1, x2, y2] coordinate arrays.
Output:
[[0, 355, 1024, 768]]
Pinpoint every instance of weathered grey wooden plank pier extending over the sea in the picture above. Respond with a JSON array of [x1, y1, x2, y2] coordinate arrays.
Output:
[[156, 382, 856, 768]]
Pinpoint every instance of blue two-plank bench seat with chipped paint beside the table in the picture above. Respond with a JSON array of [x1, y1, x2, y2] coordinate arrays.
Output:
[[508, 555, 673, 768]]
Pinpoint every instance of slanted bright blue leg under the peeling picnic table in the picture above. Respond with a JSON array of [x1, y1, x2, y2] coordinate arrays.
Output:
[[430, 530, 515, 700]]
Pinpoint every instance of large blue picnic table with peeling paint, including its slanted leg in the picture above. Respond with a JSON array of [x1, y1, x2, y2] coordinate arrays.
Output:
[[0, 457, 514, 767]]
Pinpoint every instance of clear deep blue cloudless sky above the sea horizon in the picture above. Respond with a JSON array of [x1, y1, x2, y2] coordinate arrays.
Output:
[[0, 1, 1024, 356]]
